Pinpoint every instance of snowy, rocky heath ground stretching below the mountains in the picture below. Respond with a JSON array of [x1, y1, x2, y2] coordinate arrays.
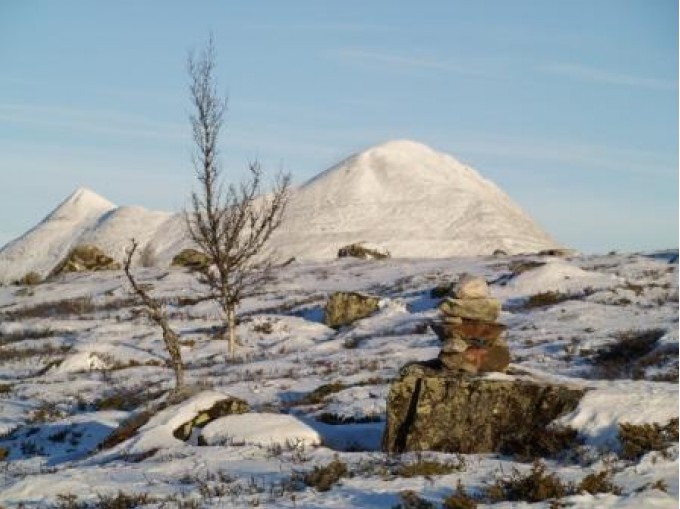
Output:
[[0, 251, 678, 508]]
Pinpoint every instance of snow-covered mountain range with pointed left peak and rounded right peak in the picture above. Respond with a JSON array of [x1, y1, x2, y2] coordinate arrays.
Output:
[[0, 141, 558, 282]]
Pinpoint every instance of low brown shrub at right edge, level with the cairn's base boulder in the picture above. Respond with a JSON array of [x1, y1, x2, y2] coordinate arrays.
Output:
[[619, 417, 678, 461]]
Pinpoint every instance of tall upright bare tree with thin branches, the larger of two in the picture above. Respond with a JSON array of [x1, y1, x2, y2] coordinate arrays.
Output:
[[186, 37, 290, 358]]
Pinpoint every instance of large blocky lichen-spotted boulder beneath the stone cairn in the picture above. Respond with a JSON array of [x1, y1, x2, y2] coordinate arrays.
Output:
[[382, 365, 585, 454]]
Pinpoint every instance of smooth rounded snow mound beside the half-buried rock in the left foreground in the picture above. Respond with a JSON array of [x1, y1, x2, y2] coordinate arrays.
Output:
[[201, 413, 321, 449]]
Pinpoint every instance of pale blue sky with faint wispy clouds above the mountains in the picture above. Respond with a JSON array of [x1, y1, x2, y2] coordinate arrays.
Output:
[[0, 0, 678, 253]]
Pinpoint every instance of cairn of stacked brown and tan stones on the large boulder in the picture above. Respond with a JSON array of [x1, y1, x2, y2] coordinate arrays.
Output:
[[431, 276, 510, 374]]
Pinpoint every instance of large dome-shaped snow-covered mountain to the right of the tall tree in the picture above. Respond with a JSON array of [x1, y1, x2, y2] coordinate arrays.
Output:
[[272, 141, 557, 259]]
